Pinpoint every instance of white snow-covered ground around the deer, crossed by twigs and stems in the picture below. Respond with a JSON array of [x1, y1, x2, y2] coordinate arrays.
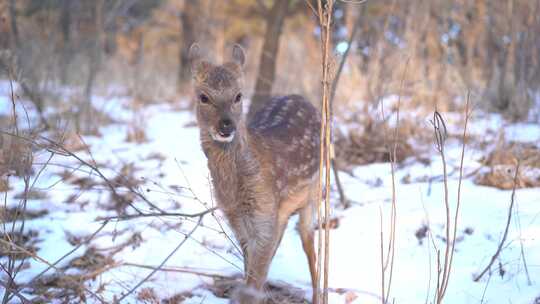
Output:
[[0, 85, 540, 304]]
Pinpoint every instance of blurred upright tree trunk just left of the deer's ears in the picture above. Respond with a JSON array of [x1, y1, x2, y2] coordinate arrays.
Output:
[[177, 1, 200, 90]]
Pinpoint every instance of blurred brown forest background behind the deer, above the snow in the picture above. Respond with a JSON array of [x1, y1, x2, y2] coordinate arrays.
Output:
[[0, 0, 540, 133]]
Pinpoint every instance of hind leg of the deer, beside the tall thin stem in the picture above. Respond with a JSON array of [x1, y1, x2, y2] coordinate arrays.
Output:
[[297, 195, 317, 304]]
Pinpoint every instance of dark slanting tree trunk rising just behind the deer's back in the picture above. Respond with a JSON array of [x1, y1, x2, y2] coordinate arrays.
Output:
[[249, 0, 289, 116]]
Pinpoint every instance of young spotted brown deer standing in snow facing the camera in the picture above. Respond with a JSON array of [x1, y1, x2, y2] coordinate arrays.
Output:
[[189, 44, 321, 304]]
